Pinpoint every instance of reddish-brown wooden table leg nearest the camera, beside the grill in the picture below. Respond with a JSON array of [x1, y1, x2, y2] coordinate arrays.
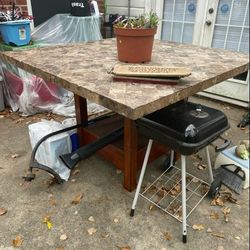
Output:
[[123, 118, 138, 192]]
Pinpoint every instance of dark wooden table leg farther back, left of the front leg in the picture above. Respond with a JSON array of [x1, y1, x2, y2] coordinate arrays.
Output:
[[74, 94, 88, 146]]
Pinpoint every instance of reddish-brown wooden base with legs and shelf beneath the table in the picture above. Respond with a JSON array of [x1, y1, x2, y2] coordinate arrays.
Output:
[[75, 96, 168, 192]]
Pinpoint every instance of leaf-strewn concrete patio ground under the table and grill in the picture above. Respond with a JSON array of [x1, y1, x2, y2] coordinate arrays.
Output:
[[0, 94, 249, 250]]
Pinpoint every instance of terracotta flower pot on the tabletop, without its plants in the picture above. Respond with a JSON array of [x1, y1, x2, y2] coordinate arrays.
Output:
[[114, 27, 156, 63]]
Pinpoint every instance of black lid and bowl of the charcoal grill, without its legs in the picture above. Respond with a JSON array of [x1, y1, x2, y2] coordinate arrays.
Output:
[[136, 101, 229, 155]]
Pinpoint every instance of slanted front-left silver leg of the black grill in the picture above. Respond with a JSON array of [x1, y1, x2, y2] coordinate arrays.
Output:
[[130, 139, 153, 217]]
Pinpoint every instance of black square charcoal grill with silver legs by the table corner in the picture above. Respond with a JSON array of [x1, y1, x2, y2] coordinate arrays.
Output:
[[130, 101, 230, 243]]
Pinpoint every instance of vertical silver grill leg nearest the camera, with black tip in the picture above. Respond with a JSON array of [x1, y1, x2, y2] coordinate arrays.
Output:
[[181, 155, 187, 243]]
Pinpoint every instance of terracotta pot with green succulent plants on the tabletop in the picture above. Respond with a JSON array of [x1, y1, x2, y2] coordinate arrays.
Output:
[[114, 11, 159, 63]]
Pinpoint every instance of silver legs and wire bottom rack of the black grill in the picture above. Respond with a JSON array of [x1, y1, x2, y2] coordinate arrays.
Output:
[[130, 144, 213, 243]]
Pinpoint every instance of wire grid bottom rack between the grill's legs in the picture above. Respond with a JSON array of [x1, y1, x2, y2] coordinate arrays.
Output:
[[140, 166, 209, 225]]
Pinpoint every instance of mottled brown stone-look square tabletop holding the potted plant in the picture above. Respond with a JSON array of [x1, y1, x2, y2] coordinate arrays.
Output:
[[0, 39, 249, 120]]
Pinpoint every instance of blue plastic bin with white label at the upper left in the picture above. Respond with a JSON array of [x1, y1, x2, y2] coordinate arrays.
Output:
[[0, 20, 31, 46]]
